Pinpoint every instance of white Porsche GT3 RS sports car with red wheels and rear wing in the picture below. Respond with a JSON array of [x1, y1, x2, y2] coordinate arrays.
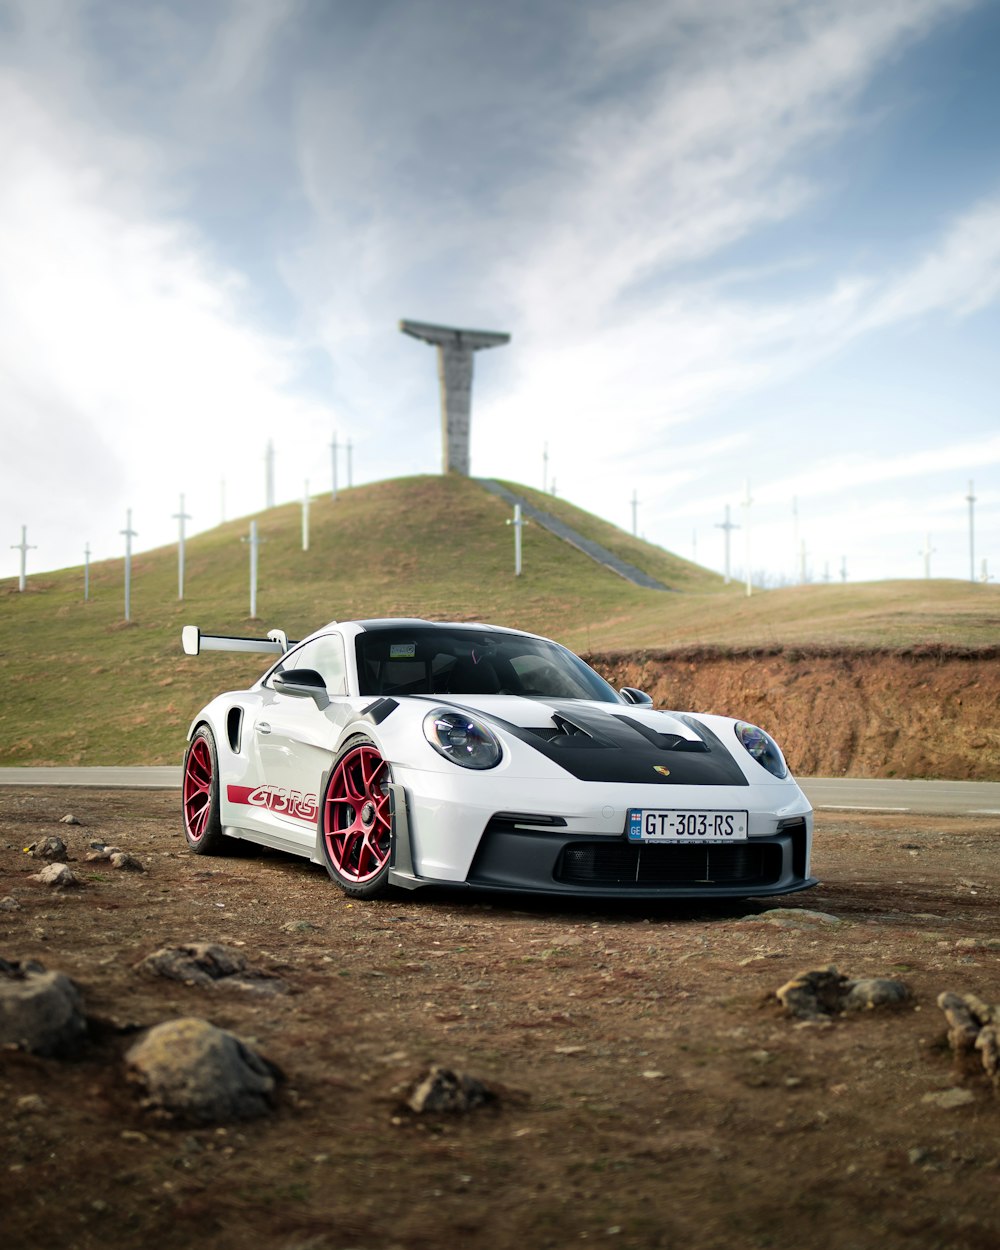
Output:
[[183, 620, 816, 898]]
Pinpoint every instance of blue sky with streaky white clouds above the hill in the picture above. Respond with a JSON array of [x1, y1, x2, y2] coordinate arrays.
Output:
[[0, 0, 1000, 585]]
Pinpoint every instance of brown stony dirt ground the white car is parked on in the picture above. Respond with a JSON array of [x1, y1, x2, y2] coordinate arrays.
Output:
[[0, 788, 1000, 1250]]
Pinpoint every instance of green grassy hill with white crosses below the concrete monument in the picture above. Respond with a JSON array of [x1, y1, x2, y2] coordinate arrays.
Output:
[[0, 476, 1000, 765]]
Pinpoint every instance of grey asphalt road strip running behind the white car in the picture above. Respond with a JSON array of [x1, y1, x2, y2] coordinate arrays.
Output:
[[0, 766, 1000, 816]]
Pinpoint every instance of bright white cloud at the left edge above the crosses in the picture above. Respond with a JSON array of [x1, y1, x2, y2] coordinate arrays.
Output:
[[0, 69, 329, 572]]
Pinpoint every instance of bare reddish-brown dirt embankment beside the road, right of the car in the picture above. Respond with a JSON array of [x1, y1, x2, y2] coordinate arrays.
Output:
[[588, 646, 1000, 781]]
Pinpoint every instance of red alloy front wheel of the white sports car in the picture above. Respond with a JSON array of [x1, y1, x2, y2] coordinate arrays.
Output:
[[323, 743, 393, 885]]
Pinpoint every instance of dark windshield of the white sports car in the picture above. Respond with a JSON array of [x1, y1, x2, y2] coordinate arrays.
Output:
[[356, 625, 621, 703]]
